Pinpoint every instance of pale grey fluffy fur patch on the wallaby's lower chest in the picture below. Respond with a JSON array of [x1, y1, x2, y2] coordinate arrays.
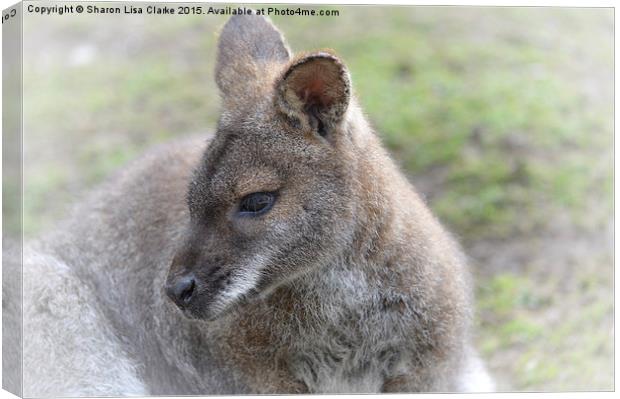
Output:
[[280, 265, 406, 393]]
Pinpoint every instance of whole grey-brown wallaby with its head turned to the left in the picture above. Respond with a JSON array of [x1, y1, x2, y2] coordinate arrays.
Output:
[[5, 15, 492, 396]]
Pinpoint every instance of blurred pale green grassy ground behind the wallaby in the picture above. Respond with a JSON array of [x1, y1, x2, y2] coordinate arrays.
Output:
[[19, 2, 614, 391]]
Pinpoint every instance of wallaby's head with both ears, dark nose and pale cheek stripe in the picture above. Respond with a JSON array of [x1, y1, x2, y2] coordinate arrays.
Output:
[[166, 15, 366, 319]]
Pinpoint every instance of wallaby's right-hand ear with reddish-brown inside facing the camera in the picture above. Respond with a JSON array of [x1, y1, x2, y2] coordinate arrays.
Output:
[[275, 52, 351, 136]]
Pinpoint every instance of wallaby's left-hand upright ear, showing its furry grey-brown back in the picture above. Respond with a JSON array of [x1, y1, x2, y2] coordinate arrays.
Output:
[[215, 15, 290, 96]]
